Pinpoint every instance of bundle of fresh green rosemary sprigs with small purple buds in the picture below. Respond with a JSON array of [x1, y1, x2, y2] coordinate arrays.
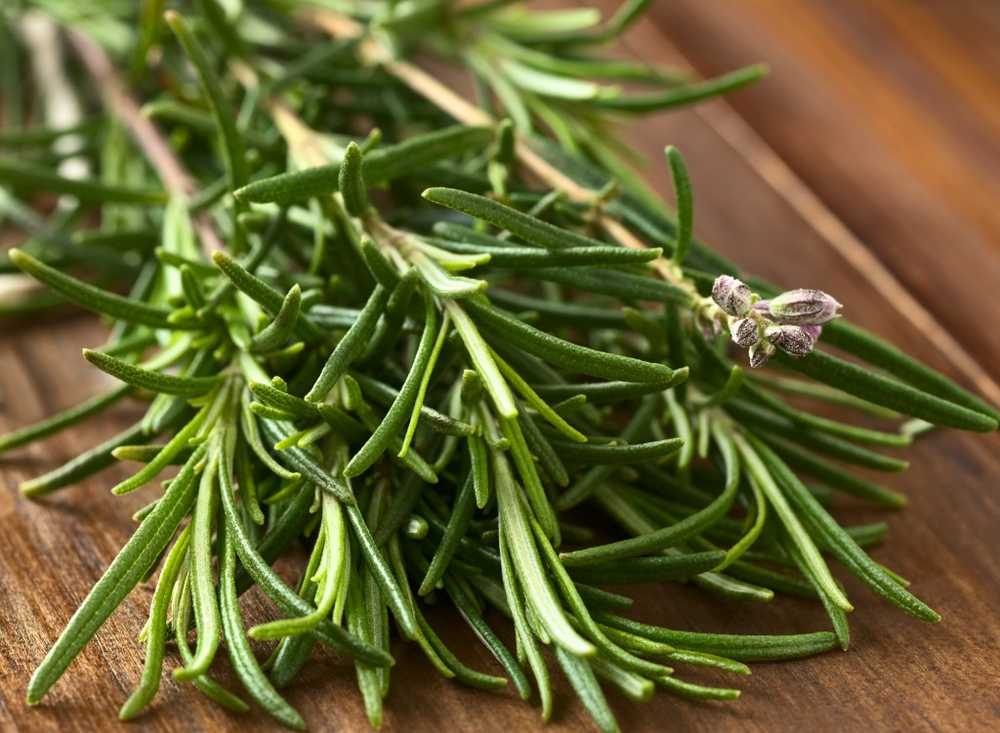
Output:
[[0, 0, 1000, 731]]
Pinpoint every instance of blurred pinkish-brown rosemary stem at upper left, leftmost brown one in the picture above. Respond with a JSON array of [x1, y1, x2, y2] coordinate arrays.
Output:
[[69, 30, 225, 255]]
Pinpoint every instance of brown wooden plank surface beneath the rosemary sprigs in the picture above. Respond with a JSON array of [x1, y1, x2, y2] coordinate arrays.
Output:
[[0, 0, 1000, 732]]
